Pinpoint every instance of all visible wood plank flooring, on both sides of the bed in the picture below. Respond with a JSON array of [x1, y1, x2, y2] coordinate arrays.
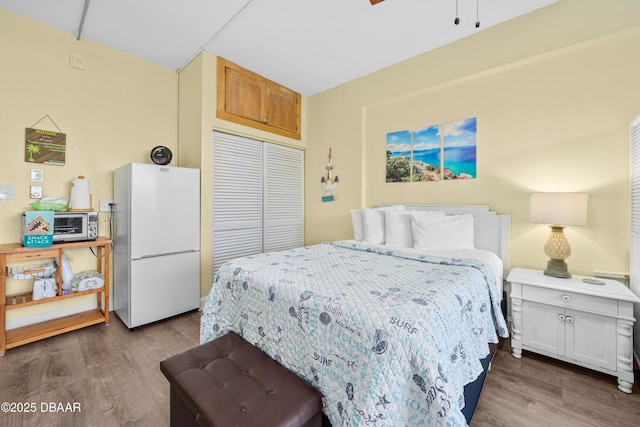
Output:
[[0, 312, 640, 427]]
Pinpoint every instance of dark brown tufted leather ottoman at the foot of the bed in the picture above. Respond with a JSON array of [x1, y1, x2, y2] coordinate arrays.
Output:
[[160, 332, 322, 427]]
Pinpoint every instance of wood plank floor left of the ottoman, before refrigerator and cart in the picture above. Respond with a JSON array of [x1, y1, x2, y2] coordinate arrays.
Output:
[[0, 312, 200, 427]]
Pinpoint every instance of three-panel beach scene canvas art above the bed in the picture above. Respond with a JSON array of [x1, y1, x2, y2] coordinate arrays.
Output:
[[386, 117, 477, 182]]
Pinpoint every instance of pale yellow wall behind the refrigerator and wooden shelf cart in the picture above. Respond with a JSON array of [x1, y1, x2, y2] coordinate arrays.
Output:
[[0, 9, 178, 319]]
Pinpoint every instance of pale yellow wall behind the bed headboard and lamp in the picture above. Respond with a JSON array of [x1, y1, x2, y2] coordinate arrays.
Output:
[[305, 0, 640, 275]]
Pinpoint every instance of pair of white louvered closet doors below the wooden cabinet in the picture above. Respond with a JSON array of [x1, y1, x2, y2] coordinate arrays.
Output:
[[212, 132, 304, 275]]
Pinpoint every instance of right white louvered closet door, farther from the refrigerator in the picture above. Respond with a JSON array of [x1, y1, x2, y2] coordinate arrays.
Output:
[[264, 143, 304, 252]]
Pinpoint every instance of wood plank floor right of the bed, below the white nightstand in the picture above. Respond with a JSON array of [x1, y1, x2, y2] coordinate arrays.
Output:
[[471, 340, 640, 427]]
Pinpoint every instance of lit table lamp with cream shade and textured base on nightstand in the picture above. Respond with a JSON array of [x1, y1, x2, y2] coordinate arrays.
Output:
[[529, 193, 589, 279]]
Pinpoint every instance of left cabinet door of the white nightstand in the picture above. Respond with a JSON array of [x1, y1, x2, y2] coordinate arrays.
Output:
[[522, 301, 565, 356]]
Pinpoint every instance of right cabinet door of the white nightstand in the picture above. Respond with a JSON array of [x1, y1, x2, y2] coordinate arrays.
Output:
[[565, 309, 616, 370]]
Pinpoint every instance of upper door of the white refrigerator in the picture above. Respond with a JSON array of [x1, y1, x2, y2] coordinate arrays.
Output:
[[130, 163, 200, 259]]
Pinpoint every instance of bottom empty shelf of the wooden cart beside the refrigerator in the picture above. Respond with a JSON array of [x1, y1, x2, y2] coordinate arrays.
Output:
[[6, 309, 105, 348]]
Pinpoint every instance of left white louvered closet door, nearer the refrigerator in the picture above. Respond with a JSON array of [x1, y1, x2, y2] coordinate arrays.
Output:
[[213, 132, 263, 274]]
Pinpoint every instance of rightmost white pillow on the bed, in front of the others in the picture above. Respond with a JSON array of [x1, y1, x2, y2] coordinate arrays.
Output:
[[411, 212, 475, 250]]
